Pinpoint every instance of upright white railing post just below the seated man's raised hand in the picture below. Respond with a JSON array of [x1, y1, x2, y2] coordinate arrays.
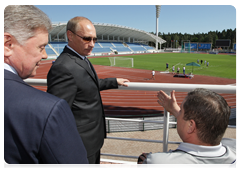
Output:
[[163, 92, 170, 152]]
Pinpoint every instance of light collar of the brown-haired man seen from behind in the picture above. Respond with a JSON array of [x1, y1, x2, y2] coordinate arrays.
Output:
[[177, 142, 226, 157]]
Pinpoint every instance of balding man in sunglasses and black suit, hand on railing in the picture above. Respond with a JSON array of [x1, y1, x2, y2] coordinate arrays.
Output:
[[47, 17, 129, 168]]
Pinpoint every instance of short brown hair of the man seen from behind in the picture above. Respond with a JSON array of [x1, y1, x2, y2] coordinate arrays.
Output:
[[183, 88, 231, 145]]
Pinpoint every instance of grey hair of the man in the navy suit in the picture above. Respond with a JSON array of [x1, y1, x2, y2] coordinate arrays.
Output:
[[4, 5, 52, 45]]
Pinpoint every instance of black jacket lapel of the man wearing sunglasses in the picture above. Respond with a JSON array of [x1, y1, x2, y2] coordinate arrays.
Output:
[[63, 47, 99, 86]]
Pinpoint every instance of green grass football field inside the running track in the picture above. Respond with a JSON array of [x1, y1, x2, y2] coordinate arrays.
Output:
[[89, 53, 238, 79]]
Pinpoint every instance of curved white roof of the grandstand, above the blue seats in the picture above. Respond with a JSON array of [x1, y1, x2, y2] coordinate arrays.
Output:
[[49, 23, 166, 44]]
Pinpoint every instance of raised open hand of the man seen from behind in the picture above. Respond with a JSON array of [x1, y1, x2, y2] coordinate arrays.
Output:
[[157, 90, 180, 118]]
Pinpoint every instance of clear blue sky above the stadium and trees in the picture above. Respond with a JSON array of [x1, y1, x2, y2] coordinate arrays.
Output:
[[36, 5, 238, 34]]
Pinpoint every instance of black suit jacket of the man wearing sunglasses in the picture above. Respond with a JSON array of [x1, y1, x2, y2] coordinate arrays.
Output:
[[47, 47, 118, 156]]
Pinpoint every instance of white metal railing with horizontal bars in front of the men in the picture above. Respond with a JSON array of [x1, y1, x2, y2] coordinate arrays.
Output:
[[25, 79, 238, 158]]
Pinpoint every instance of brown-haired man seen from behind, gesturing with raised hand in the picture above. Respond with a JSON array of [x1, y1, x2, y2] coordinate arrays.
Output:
[[138, 89, 238, 168]]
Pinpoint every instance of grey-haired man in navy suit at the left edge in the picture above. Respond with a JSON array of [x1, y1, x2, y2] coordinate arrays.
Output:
[[4, 5, 88, 168]]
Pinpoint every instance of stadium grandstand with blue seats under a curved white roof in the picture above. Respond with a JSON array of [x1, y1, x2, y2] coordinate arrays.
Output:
[[46, 23, 166, 58]]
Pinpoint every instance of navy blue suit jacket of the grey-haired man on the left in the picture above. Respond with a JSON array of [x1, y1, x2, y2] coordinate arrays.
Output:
[[4, 70, 88, 168]]
